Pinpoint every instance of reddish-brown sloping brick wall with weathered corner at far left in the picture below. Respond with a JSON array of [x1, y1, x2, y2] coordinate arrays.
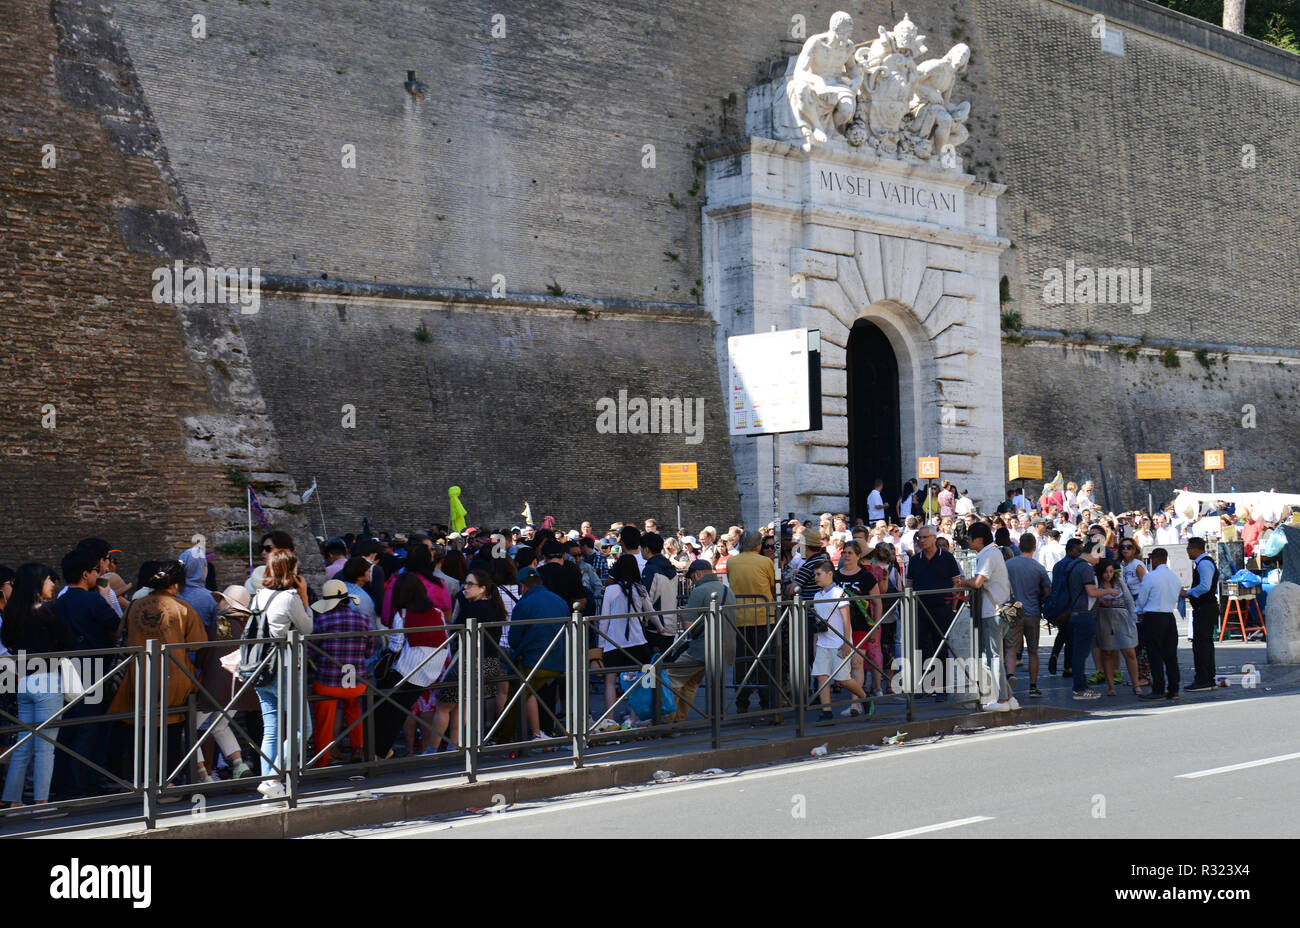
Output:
[[0, 3, 320, 580]]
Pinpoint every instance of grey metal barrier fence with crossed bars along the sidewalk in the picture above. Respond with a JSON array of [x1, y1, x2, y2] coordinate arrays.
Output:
[[0, 590, 987, 831]]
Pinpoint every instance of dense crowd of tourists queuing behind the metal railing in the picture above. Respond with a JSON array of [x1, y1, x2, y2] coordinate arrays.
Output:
[[0, 481, 1290, 806]]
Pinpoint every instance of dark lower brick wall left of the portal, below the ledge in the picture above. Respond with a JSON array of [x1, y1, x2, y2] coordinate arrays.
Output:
[[237, 295, 738, 533]]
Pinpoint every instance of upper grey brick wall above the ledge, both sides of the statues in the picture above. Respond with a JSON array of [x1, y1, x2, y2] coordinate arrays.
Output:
[[109, 0, 1300, 346]]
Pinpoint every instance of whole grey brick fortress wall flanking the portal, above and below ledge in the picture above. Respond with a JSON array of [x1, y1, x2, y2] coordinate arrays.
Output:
[[5, 0, 1300, 564]]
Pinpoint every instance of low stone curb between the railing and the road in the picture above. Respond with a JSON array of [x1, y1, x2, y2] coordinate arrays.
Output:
[[114, 706, 1088, 840]]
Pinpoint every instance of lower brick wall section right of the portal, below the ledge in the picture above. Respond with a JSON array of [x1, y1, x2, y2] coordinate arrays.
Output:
[[1002, 344, 1300, 511]]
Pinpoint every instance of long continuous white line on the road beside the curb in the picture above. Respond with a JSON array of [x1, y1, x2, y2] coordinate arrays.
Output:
[[340, 699, 1284, 838]]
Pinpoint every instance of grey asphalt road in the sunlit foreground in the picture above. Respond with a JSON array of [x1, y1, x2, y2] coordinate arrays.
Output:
[[312, 694, 1300, 838]]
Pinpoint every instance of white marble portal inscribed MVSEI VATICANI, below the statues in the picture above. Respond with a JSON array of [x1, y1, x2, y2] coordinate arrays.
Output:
[[702, 138, 1009, 525]]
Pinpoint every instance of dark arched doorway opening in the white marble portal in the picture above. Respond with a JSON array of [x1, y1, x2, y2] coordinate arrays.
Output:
[[846, 318, 902, 519]]
